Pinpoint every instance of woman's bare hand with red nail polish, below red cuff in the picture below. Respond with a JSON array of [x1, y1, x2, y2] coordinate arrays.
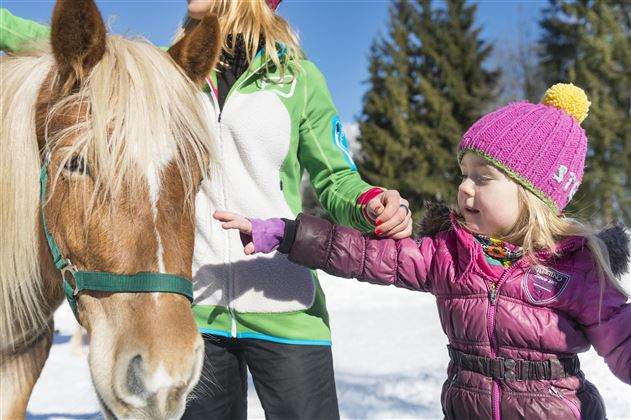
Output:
[[366, 190, 412, 239]]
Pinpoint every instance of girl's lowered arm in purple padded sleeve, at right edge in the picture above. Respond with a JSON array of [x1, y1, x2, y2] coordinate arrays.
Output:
[[579, 273, 631, 384]]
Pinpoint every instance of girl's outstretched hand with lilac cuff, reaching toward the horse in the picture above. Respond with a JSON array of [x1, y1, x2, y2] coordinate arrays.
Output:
[[213, 211, 285, 255]]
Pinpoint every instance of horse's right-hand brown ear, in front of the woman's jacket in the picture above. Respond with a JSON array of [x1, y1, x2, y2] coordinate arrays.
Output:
[[168, 15, 221, 86]]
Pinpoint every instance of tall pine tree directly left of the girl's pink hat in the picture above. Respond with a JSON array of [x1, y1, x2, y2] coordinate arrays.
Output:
[[359, 0, 498, 209]]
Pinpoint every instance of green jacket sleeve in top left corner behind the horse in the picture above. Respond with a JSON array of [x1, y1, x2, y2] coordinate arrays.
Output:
[[0, 8, 50, 52]]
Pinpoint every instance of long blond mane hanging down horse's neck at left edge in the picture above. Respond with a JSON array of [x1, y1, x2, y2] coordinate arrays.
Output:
[[0, 48, 54, 351]]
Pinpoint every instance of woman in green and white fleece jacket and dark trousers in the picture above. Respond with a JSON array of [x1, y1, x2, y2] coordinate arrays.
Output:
[[0, 0, 412, 419]]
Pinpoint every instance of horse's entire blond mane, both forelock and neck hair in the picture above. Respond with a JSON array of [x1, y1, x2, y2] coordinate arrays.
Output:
[[0, 36, 214, 350]]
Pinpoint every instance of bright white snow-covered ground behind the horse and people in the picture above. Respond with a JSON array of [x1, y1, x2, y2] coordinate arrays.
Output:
[[27, 274, 631, 420]]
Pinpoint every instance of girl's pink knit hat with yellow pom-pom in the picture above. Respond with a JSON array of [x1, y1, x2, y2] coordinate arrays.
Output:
[[458, 84, 590, 212]]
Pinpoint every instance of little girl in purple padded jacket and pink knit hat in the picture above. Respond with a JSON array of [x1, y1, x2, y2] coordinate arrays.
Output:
[[215, 84, 631, 420]]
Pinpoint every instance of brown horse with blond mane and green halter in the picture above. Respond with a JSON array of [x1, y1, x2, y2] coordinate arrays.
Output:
[[0, 0, 221, 418]]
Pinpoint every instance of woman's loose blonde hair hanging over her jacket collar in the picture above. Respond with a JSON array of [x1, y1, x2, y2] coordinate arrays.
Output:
[[175, 0, 302, 74]]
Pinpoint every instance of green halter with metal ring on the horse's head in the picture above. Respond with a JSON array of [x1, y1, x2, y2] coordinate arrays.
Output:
[[39, 155, 193, 321]]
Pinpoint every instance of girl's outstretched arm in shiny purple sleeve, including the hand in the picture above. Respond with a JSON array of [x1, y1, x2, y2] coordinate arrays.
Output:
[[213, 212, 434, 291]]
